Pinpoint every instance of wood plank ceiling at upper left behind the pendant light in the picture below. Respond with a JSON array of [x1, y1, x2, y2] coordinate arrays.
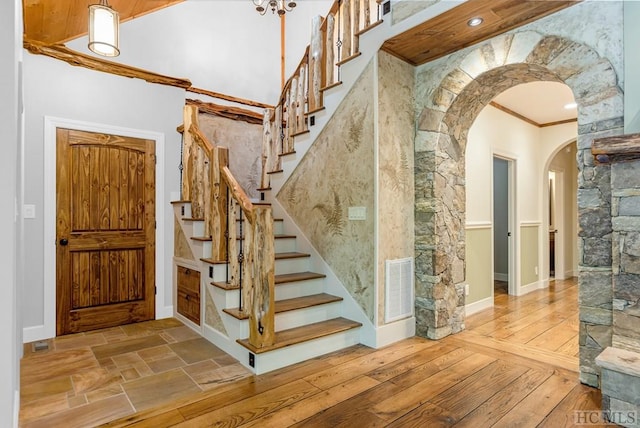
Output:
[[22, 0, 184, 44]]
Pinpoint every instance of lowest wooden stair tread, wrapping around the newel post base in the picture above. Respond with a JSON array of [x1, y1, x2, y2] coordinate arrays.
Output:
[[237, 318, 362, 354]]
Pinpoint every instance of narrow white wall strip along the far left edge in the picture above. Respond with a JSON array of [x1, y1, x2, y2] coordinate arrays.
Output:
[[0, 0, 22, 427]]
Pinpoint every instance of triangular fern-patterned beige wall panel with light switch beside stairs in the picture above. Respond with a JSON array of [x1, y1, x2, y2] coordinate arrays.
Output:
[[277, 63, 375, 320]]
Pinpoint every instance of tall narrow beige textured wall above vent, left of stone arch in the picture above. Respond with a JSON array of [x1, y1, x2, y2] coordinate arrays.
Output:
[[377, 51, 415, 324]]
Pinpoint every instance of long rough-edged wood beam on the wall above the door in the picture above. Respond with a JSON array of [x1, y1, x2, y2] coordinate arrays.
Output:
[[23, 39, 191, 89]]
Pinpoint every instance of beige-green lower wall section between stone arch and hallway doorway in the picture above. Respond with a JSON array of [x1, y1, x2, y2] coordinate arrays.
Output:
[[465, 226, 493, 305]]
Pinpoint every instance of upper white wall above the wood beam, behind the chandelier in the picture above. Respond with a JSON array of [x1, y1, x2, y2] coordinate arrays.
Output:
[[67, 0, 332, 104]]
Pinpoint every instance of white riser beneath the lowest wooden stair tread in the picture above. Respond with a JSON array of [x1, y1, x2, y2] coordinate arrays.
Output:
[[249, 328, 360, 374]]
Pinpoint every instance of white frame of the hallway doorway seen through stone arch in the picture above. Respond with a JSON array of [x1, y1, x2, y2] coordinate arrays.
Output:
[[491, 150, 520, 297]]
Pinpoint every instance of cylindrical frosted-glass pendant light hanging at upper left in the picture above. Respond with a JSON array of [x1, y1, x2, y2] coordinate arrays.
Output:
[[88, 0, 120, 56]]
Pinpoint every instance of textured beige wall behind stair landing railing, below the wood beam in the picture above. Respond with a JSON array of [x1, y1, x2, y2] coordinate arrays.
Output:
[[198, 113, 262, 198]]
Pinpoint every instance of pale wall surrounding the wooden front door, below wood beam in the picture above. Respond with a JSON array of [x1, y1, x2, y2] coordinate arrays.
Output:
[[22, 54, 184, 340]]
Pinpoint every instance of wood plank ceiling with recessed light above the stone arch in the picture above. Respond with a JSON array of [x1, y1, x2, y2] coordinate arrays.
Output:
[[382, 0, 580, 65]]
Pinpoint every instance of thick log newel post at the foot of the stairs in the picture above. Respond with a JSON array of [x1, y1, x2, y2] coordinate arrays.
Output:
[[247, 207, 275, 348]]
